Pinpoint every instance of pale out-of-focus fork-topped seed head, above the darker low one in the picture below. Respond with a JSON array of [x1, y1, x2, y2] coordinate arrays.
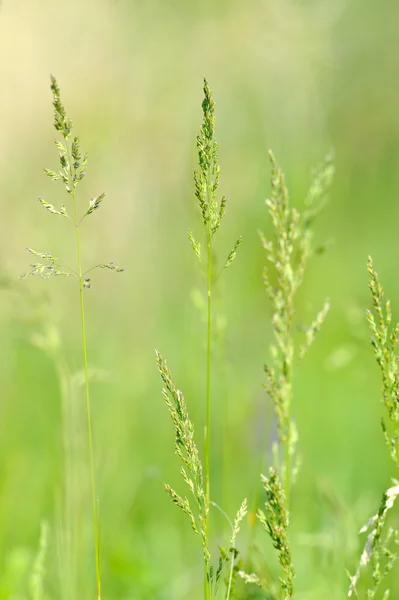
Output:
[[260, 152, 334, 510]]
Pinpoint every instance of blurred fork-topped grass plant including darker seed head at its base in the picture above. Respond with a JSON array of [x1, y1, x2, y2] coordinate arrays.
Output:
[[241, 152, 334, 600]]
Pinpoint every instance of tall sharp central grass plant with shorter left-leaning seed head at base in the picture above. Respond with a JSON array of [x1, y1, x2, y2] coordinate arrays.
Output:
[[157, 79, 247, 600]]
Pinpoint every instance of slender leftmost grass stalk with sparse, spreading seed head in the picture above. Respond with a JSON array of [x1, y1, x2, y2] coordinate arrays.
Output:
[[22, 76, 123, 600]]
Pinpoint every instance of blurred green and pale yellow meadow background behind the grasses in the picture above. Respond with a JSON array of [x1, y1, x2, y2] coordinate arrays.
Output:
[[0, 0, 399, 600]]
